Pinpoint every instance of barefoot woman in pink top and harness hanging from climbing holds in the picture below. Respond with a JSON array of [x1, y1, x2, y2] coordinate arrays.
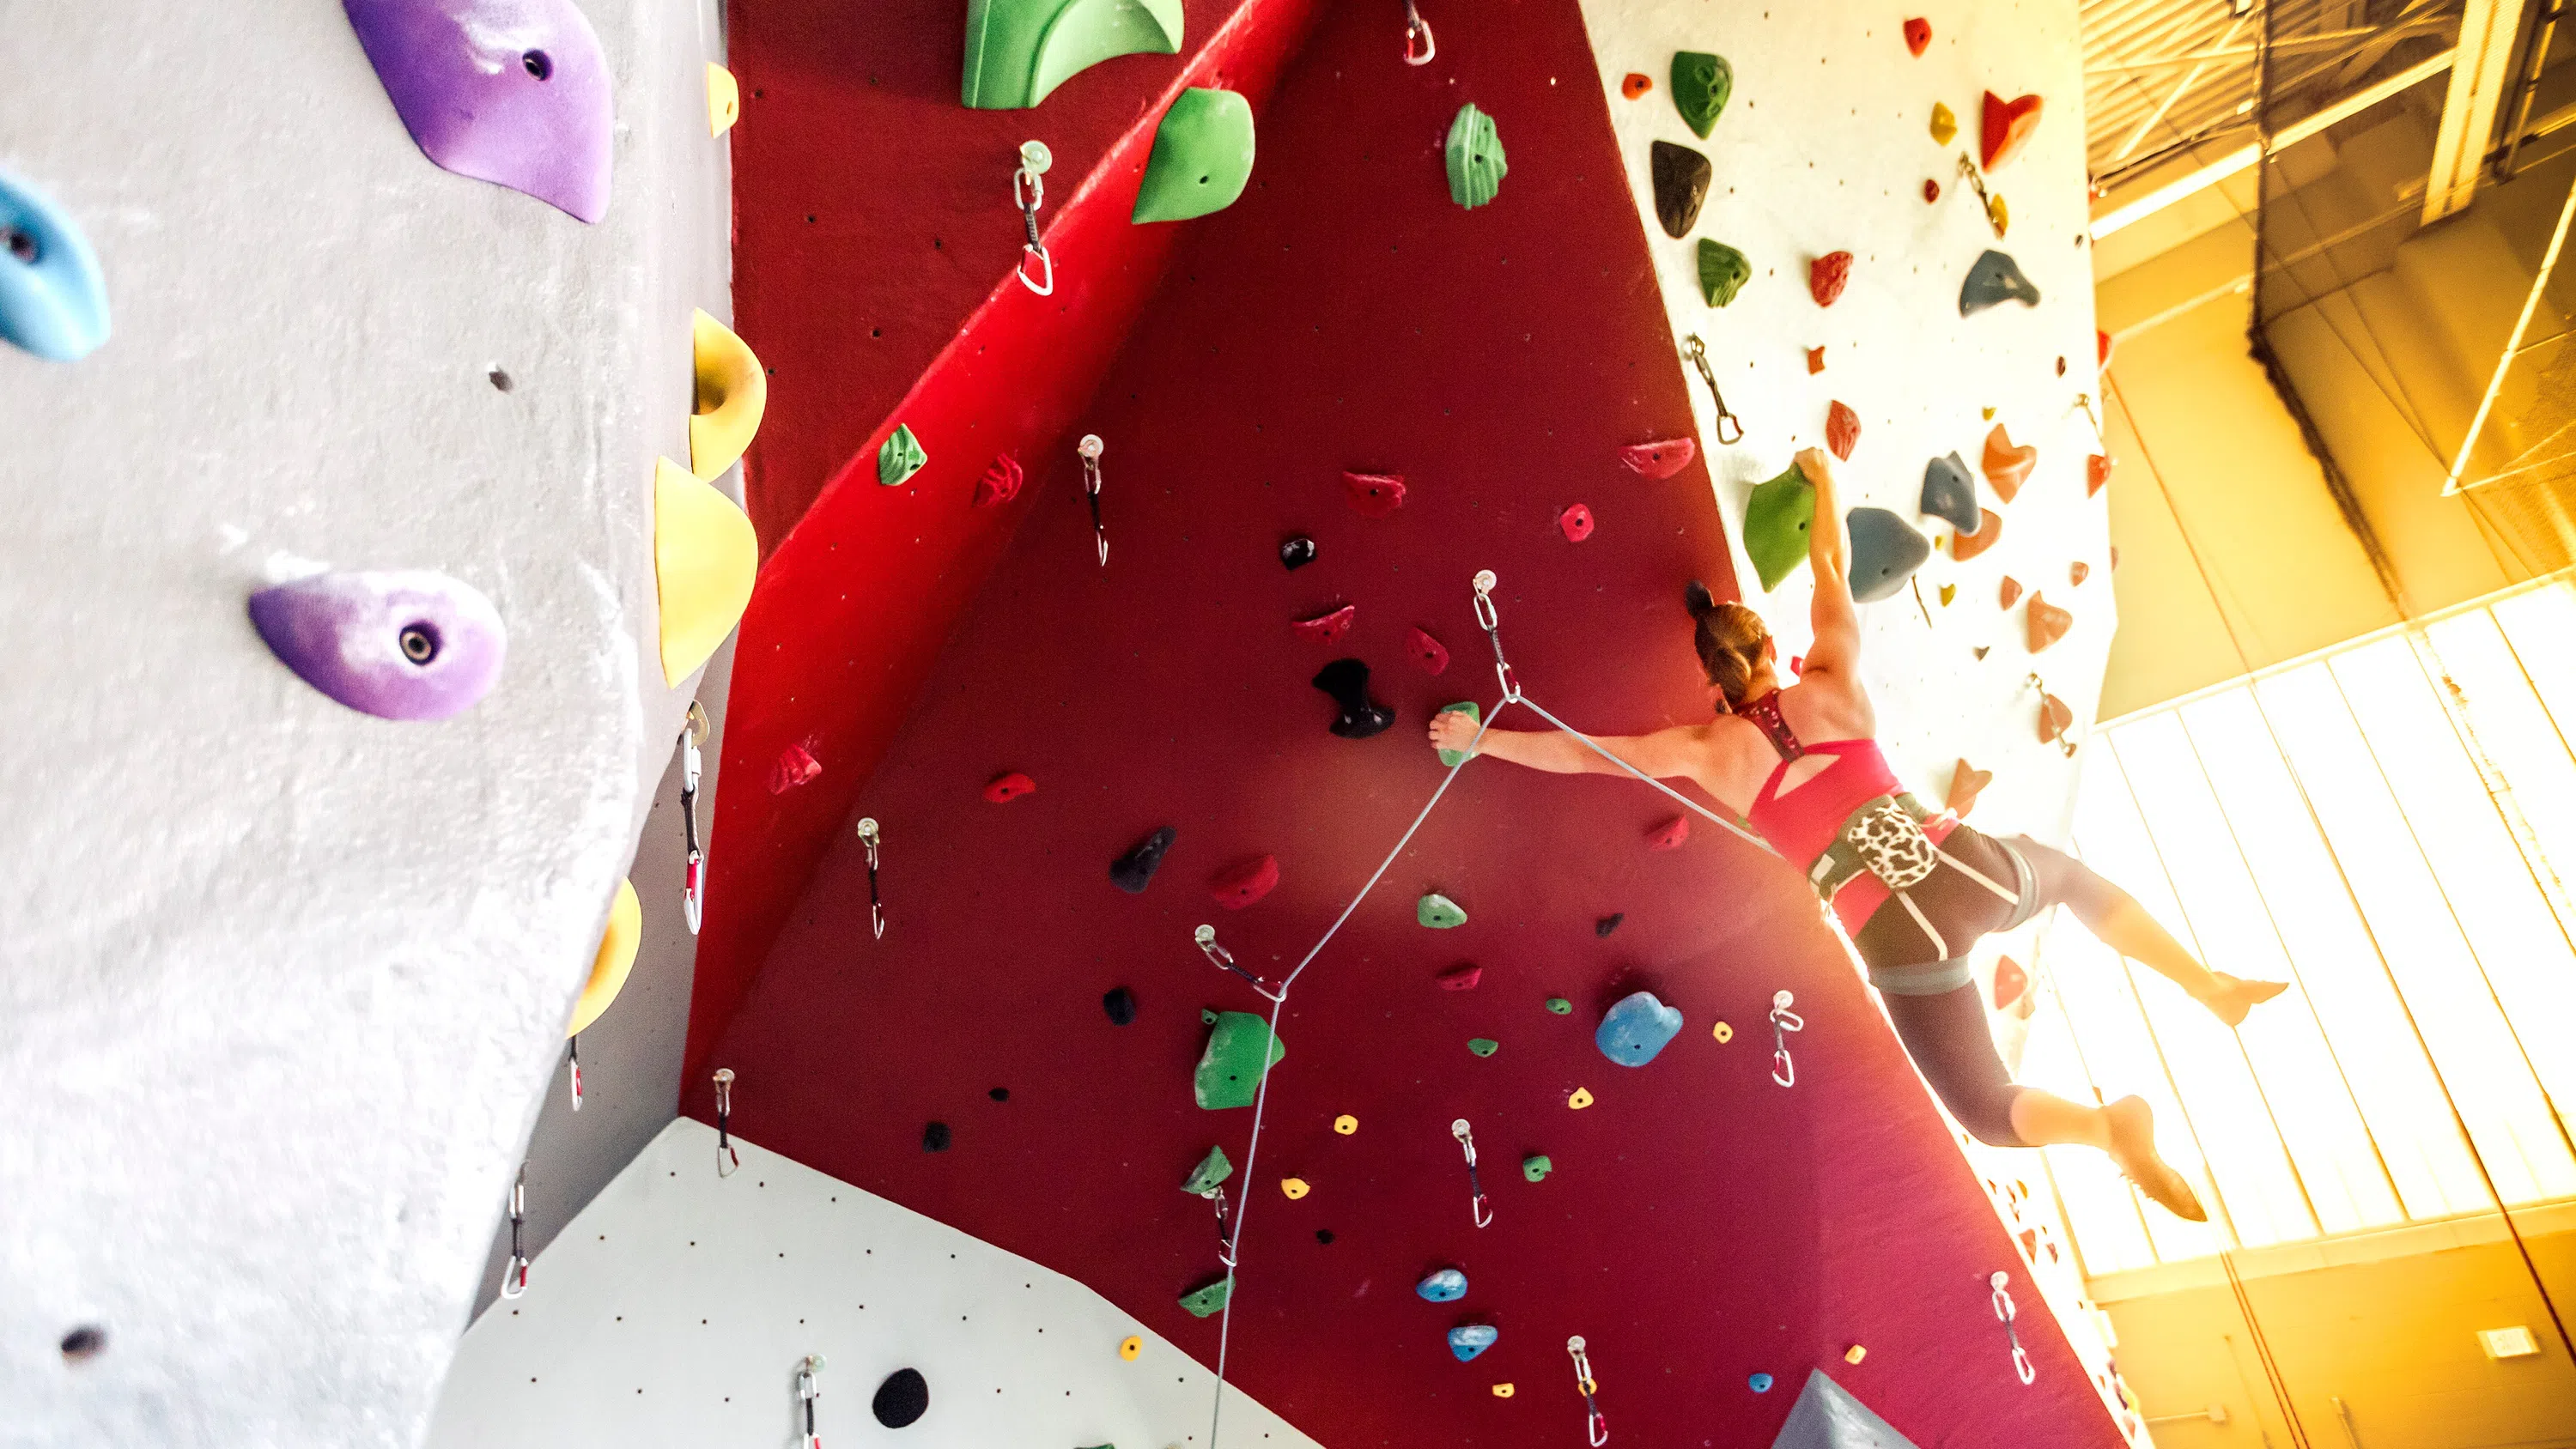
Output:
[[1430, 448, 2285, 1222]]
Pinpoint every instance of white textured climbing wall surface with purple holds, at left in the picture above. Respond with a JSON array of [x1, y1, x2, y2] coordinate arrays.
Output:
[[0, 0, 729, 1449]]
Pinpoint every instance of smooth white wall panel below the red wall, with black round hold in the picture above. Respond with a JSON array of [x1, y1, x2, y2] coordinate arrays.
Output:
[[428, 1117, 1314, 1449]]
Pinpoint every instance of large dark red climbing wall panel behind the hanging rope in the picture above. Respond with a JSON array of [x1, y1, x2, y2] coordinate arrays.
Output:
[[685, 0, 2117, 1449]]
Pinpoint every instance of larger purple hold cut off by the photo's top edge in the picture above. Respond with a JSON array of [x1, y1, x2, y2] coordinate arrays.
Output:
[[343, 0, 616, 221]]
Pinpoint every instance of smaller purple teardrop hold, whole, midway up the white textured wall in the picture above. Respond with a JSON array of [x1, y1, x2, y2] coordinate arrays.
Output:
[[250, 569, 510, 721]]
